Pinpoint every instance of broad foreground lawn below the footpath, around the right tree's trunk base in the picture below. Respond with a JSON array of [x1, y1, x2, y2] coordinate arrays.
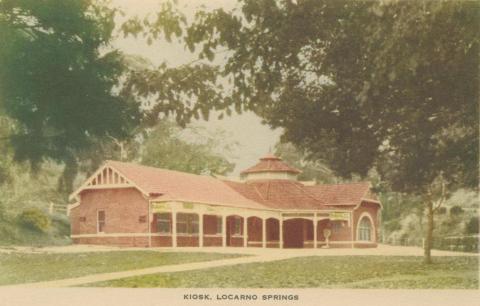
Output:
[[90, 256, 478, 289]]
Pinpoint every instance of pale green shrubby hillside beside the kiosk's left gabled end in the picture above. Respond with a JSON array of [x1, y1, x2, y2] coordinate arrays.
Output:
[[0, 160, 70, 246]]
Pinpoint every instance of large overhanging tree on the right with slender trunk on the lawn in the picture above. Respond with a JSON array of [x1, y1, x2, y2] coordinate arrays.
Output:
[[173, 0, 480, 263]]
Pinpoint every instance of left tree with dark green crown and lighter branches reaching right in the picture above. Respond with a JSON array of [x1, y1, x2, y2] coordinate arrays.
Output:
[[0, 0, 228, 194]]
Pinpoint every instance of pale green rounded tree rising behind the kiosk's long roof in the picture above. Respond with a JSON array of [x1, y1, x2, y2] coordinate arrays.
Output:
[[140, 120, 234, 175]]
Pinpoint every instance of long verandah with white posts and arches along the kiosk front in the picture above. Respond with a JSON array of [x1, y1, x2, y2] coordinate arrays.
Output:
[[150, 201, 354, 248]]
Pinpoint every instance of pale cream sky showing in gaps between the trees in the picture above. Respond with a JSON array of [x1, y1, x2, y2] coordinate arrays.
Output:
[[112, 0, 281, 176]]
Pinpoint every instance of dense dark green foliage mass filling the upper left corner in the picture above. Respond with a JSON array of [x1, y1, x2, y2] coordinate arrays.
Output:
[[0, 0, 138, 164]]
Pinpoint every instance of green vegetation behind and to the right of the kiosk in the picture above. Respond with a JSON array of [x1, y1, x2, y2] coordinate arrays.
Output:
[[275, 143, 479, 252]]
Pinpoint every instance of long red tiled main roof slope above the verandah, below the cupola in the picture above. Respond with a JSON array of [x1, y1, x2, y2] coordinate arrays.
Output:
[[96, 161, 374, 209]]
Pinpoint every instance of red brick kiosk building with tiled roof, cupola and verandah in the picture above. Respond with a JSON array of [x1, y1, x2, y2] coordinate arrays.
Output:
[[68, 155, 381, 248]]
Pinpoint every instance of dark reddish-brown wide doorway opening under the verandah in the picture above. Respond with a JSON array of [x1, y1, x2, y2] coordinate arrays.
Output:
[[283, 218, 313, 248]]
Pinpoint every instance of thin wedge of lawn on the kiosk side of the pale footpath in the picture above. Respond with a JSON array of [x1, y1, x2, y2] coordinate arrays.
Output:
[[0, 251, 241, 285]]
